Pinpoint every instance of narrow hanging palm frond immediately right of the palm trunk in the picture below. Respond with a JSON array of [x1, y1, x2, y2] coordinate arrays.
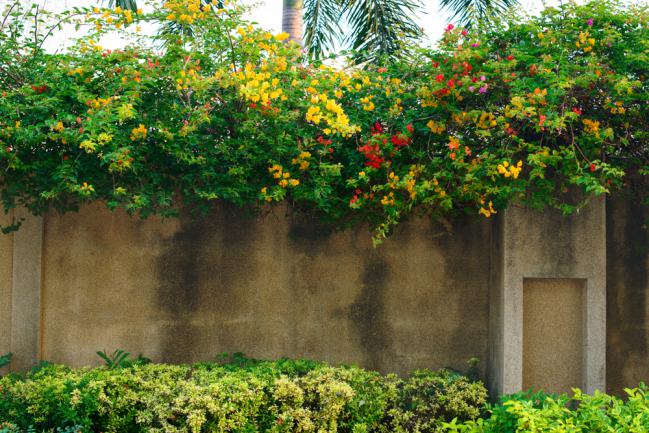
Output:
[[304, 0, 342, 59]]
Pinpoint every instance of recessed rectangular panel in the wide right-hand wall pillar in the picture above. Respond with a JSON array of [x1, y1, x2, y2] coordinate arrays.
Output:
[[523, 278, 586, 392]]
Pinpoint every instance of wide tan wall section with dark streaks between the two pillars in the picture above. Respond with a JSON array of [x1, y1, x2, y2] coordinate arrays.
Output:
[[42, 202, 492, 373]]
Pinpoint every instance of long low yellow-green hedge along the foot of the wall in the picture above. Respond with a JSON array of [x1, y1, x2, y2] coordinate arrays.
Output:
[[0, 355, 486, 433]]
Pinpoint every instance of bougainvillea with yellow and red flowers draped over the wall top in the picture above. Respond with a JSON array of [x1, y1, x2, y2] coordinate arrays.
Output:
[[0, 0, 649, 239]]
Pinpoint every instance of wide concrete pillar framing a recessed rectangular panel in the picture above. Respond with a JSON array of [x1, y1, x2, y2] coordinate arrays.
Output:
[[489, 197, 606, 395]]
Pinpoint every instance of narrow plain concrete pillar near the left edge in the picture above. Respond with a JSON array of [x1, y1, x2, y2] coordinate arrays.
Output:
[[11, 209, 43, 371]]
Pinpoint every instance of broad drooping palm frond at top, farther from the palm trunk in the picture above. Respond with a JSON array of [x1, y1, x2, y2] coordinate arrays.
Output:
[[345, 0, 422, 63]]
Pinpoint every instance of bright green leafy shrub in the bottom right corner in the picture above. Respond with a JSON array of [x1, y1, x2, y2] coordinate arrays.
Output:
[[442, 384, 649, 433]]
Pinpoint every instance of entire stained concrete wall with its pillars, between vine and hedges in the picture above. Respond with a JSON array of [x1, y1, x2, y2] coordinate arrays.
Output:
[[0, 186, 649, 393]]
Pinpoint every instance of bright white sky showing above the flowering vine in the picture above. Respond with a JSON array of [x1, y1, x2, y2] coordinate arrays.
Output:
[[0, 0, 581, 48]]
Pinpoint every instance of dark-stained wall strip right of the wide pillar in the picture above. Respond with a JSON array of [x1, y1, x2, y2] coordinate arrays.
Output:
[[607, 184, 649, 394]]
